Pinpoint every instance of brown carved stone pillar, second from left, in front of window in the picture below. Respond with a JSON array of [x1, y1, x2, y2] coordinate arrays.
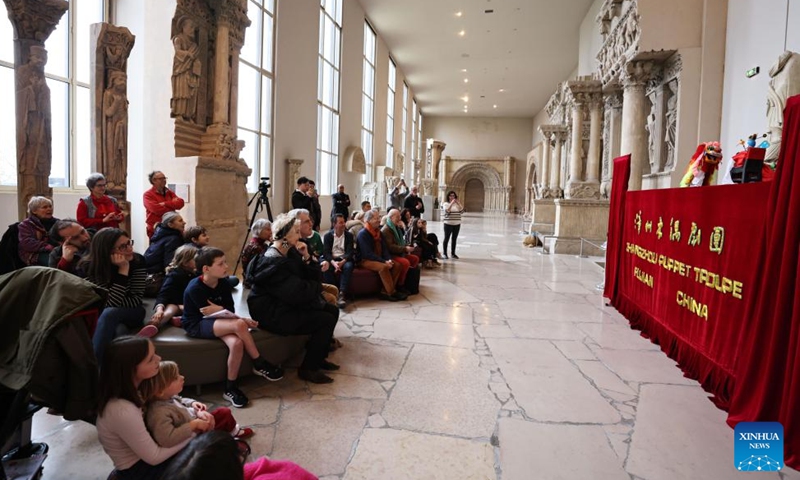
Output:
[[91, 23, 136, 232]]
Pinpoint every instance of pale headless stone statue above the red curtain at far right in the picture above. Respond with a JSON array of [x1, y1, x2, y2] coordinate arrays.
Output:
[[765, 50, 800, 165]]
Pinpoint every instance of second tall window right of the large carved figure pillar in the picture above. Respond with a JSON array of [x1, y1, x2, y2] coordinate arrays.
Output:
[[317, 0, 342, 195]]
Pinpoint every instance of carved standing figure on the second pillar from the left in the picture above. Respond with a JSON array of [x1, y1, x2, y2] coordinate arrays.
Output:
[[103, 71, 128, 188]]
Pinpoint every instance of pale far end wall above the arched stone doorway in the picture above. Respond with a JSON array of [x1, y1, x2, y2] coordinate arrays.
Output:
[[422, 117, 538, 208]]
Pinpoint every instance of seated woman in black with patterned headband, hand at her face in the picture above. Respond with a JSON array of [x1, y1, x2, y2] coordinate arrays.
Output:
[[247, 214, 339, 383]]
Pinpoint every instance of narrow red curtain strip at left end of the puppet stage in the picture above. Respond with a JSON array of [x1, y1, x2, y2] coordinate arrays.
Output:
[[603, 155, 631, 301]]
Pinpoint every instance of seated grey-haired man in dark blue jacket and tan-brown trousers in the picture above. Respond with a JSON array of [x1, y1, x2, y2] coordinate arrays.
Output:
[[356, 210, 408, 302]]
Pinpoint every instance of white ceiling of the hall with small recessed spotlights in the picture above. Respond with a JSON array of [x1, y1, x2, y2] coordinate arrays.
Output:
[[359, 0, 592, 117]]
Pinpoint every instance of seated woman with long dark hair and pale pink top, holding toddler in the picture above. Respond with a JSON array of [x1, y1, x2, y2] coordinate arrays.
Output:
[[97, 337, 194, 480]]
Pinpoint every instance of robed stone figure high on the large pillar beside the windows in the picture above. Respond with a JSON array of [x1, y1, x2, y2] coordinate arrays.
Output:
[[171, 17, 203, 121]]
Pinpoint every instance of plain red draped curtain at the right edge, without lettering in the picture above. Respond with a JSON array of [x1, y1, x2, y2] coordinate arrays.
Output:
[[728, 96, 800, 469]]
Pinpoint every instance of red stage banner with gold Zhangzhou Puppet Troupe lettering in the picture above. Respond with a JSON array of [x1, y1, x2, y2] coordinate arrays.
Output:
[[612, 183, 770, 408]]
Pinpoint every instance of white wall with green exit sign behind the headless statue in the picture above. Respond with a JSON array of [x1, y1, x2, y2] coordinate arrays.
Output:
[[719, 0, 800, 181]]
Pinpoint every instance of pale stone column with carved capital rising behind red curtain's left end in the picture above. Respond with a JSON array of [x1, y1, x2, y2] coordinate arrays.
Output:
[[620, 60, 654, 190]]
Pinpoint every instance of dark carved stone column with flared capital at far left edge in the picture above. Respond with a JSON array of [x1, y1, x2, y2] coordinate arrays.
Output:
[[3, 0, 69, 220]]
